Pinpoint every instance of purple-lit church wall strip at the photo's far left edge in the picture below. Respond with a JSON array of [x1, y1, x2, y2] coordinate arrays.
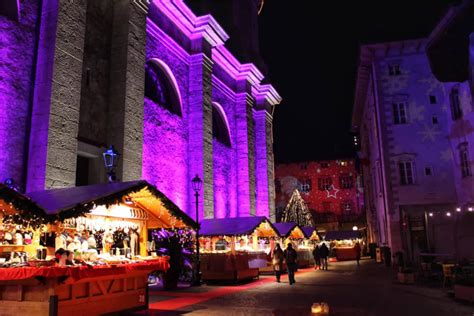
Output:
[[0, 0, 38, 187]]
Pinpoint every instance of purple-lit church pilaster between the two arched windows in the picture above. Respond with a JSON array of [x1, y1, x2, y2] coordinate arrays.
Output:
[[188, 53, 214, 219]]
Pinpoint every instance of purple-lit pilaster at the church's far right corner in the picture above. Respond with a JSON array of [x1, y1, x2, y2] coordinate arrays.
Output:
[[254, 110, 275, 221]]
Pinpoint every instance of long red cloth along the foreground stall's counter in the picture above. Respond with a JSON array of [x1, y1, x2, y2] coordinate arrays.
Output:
[[0, 258, 169, 281]]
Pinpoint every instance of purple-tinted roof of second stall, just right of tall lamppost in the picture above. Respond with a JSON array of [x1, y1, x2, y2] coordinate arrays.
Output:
[[199, 216, 278, 237]]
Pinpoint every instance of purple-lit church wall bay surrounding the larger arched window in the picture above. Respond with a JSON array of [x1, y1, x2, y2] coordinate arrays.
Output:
[[142, 21, 192, 214]]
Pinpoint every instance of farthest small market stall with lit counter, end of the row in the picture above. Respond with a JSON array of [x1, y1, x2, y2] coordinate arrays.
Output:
[[324, 230, 362, 261]]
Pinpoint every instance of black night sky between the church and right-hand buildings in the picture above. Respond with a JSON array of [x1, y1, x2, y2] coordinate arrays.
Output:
[[259, 0, 459, 163]]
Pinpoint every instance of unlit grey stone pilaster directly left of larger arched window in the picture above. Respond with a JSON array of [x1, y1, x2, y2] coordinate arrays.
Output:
[[107, 0, 147, 181]]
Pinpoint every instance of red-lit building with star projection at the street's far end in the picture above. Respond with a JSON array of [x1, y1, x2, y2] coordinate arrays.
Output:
[[275, 159, 365, 230]]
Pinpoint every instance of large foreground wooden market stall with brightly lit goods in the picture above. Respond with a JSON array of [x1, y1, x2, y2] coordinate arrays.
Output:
[[0, 181, 196, 315]]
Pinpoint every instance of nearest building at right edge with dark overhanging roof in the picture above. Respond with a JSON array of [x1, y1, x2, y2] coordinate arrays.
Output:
[[426, 1, 474, 258]]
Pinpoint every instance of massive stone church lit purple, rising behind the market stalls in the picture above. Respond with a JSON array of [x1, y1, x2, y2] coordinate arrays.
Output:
[[0, 0, 281, 222]]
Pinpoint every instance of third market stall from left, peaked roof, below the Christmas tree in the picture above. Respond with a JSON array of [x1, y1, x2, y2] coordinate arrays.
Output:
[[274, 223, 314, 268]]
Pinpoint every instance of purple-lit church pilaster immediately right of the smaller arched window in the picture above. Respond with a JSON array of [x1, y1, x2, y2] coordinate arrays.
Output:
[[235, 92, 255, 217]]
